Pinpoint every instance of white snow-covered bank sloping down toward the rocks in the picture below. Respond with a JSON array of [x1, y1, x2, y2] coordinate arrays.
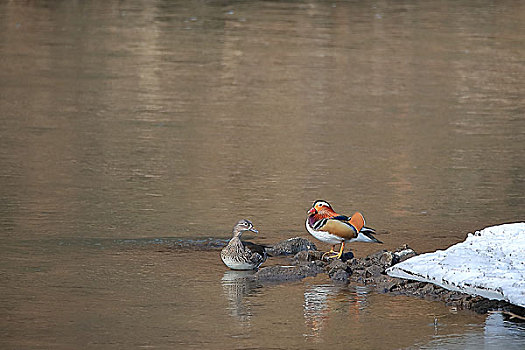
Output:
[[386, 222, 525, 307]]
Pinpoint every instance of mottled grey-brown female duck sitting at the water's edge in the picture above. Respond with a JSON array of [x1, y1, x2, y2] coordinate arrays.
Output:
[[221, 219, 267, 270]]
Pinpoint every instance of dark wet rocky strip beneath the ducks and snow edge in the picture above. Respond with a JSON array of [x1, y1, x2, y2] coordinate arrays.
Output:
[[255, 237, 525, 320]]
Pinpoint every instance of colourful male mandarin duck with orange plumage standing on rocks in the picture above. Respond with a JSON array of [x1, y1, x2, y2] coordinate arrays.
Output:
[[306, 200, 383, 259]]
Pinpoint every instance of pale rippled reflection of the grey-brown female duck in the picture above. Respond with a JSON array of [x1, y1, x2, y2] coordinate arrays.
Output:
[[221, 270, 258, 325]]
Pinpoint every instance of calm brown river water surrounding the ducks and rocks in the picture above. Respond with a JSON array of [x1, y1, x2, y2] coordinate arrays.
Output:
[[0, 0, 525, 349]]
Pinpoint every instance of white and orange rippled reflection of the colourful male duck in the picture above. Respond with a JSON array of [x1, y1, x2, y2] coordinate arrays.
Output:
[[303, 284, 368, 341]]
